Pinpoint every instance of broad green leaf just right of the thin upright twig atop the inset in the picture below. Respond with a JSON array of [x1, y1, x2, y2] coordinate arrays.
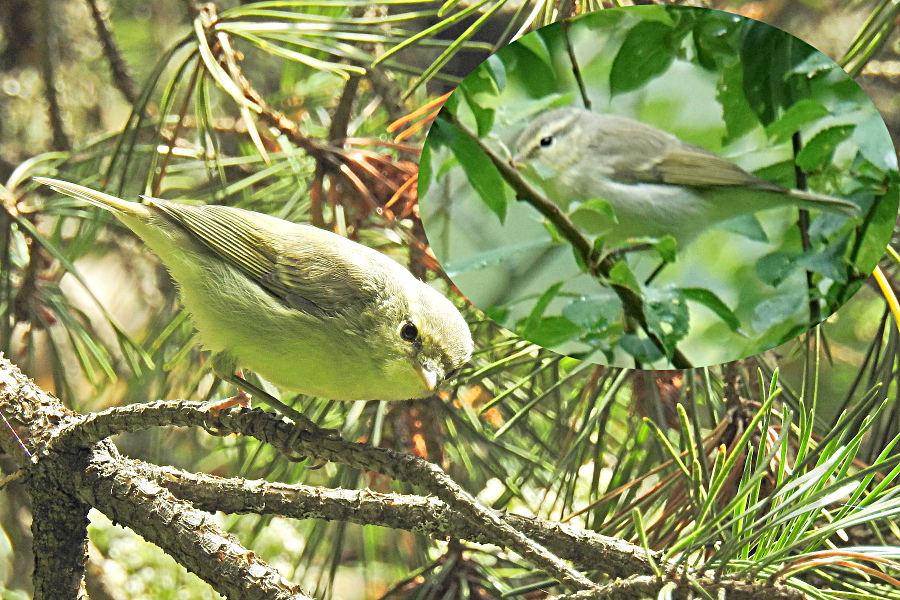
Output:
[[609, 21, 676, 96]]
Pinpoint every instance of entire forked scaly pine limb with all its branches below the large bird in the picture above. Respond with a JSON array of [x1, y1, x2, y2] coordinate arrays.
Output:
[[0, 358, 803, 600]]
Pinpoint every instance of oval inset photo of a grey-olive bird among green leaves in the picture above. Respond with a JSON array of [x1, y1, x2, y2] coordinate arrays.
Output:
[[419, 6, 898, 369]]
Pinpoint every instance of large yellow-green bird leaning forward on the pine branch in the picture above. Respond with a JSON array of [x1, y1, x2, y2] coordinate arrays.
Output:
[[35, 177, 472, 400]]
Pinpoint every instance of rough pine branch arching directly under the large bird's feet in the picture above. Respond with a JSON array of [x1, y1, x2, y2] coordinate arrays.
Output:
[[0, 359, 594, 590]]
